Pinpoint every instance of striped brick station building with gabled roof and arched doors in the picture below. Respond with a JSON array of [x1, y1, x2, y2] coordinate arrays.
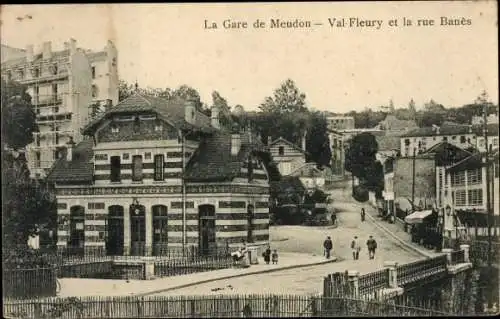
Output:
[[49, 93, 269, 255]]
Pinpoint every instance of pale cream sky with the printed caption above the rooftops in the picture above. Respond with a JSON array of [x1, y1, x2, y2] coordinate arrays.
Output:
[[0, 1, 498, 113]]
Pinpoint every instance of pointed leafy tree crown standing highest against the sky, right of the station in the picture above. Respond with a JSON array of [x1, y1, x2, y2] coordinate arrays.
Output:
[[259, 79, 307, 114]]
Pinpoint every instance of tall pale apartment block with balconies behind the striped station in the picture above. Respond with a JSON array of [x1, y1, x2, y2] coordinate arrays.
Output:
[[2, 39, 118, 178]]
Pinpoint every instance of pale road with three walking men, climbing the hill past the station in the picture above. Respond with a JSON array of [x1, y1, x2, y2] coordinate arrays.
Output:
[[151, 185, 423, 295]]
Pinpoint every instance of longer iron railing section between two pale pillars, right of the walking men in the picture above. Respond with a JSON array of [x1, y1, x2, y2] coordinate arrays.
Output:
[[396, 256, 447, 286]]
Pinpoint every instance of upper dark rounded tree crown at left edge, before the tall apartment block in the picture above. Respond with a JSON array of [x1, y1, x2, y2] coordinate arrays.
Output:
[[2, 79, 38, 150]]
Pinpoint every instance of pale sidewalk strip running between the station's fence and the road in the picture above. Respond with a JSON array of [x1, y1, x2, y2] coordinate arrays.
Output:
[[59, 253, 336, 297]]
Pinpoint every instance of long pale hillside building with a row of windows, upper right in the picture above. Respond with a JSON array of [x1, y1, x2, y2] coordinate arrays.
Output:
[[401, 124, 499, 156]]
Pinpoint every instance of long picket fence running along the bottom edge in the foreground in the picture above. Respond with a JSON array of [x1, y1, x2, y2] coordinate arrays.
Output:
[[3, 295, 454, 319]]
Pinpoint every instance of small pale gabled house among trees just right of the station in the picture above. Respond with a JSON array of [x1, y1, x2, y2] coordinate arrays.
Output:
[[269, 137, 306, 176]]
